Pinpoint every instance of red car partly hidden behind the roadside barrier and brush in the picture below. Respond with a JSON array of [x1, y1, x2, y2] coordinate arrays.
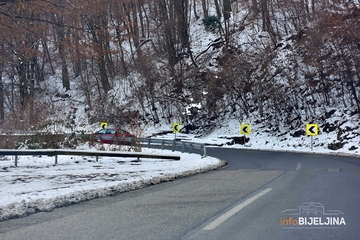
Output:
[[93, 128, 136, 145]]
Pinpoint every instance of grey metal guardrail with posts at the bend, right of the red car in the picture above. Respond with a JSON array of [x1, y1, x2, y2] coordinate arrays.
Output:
[[135, 138, 206, 157]]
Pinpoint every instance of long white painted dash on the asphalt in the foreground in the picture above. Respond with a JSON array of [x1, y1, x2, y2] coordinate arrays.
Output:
[[202, 188, 272, 230]]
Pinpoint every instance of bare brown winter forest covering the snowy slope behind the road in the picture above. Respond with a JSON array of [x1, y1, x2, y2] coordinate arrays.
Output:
[[0, 0, 360, 133]]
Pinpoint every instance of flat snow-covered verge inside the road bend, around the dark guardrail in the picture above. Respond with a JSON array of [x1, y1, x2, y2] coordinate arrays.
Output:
[[0, 148, 225, 221]]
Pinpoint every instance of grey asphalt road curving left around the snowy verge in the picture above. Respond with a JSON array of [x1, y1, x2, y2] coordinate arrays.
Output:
[[0, 148, 360, 240]]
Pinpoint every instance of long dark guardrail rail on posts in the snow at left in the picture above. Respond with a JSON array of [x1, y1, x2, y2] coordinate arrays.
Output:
[[0, 149, 180, 167]]
